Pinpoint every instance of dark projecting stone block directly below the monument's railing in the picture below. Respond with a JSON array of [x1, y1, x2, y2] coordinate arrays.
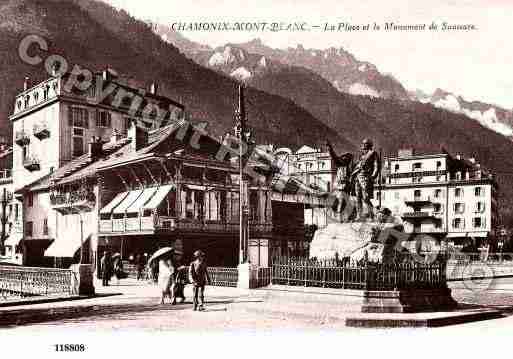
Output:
[[361, 288, 458, 313]]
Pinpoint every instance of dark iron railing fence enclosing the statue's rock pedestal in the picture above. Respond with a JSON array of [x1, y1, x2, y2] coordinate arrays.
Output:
[[271, 257, 447, 290]]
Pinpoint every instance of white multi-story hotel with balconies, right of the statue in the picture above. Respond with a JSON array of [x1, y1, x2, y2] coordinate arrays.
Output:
[[374, 150, 498, 245]]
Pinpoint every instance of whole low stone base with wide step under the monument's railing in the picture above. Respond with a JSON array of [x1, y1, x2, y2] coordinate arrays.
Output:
[[252, 285, 502, 328]]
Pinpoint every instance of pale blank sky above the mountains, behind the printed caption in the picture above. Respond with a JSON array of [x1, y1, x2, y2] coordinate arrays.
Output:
[[105, 0, 513, 109]]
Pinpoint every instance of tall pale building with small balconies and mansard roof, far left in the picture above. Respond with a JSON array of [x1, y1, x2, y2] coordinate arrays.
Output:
[[10, 69, 184, 264]]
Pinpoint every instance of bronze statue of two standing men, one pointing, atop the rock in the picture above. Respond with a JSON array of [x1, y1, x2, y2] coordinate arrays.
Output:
[[327, 138, 381, 221]]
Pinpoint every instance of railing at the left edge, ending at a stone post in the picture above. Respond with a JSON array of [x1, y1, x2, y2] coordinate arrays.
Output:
[[0, 266, 76, 300]]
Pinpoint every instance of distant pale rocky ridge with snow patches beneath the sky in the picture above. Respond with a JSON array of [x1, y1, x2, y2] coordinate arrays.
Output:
[[154, 25, 513, 138]]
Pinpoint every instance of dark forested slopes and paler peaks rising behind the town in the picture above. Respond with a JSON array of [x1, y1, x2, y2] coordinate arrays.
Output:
[[0, 0, 513, 222]]
